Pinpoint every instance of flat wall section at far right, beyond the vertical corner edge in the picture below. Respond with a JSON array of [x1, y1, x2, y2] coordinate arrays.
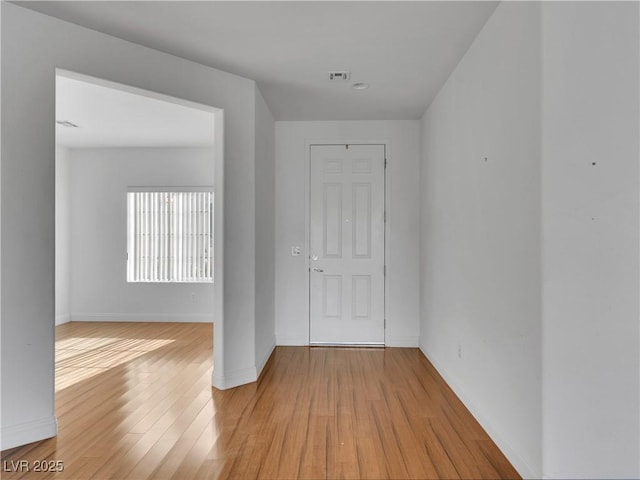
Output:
[[542, 2, 640, 478]]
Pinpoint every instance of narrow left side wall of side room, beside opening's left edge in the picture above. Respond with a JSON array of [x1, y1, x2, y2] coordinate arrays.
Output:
[[55, 145, 71, 325]]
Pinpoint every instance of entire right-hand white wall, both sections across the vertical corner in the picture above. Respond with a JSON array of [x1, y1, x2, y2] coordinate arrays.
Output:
[[421, 2, 640, 478]]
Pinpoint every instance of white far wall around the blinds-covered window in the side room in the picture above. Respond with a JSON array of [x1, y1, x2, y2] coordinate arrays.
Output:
[[68, 147, 217, 322]]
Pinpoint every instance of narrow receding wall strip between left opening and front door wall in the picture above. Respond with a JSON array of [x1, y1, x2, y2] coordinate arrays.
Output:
[[255, 89, 276, 373]]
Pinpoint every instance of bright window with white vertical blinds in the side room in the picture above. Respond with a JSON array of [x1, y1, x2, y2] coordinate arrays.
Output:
[[127, 191, 213, 283]]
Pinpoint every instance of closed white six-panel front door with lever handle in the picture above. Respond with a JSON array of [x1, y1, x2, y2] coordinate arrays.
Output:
[[309, 145, 385, 345]]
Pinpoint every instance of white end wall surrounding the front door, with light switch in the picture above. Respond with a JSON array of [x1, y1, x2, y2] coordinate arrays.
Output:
[[275, 120, 420, 347]]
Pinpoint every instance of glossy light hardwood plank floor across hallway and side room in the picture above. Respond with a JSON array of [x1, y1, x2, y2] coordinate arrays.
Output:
[[2, 323, 520, 480]]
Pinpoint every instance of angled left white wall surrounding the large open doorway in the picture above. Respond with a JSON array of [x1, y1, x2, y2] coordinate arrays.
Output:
[[0, 2, 256, 448]]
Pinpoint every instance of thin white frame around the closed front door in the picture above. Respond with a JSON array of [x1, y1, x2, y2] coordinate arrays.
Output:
[[304, 138, 391, 346]]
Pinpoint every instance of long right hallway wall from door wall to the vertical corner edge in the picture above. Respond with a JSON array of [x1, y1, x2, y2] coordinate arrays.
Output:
[[420, 2, 542, 478]]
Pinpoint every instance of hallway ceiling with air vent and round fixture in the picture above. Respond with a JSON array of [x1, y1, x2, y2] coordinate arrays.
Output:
[[14, 1, 498, 120]]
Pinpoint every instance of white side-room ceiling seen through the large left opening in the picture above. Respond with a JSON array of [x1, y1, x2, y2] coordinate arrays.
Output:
[[56, 75, 214, 148]]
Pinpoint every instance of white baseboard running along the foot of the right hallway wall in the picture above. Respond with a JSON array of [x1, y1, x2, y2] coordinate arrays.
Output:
[[420, 344, 542, 478]]
